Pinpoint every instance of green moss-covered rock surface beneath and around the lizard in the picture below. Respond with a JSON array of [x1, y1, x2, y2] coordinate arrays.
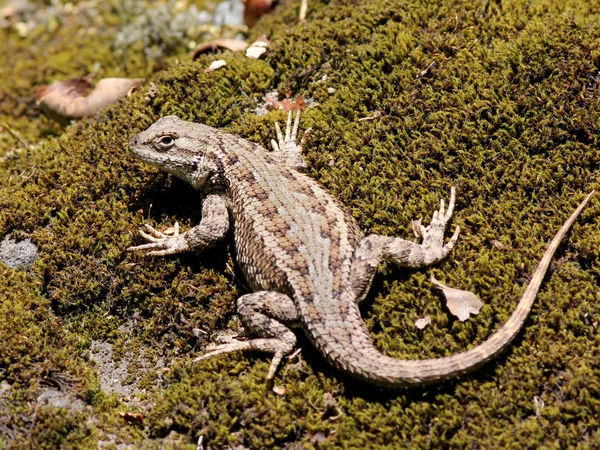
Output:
[[0, 0, 600, 448]]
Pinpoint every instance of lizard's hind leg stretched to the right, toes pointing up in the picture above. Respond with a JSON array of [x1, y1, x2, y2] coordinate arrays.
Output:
[[350, 187, 460, 302]]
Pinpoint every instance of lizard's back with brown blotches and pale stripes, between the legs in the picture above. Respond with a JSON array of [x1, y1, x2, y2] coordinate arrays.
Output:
[[223, 139, 363, 309]]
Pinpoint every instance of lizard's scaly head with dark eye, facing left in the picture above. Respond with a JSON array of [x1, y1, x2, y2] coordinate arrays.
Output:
[[129, 116, 211, 189]]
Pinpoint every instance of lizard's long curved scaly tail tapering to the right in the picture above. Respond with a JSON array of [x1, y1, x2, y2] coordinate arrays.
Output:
[[309, 191, 594, 387]]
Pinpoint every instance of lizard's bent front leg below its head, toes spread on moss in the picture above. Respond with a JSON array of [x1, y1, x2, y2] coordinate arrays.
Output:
[[127, 194, 229, 256]]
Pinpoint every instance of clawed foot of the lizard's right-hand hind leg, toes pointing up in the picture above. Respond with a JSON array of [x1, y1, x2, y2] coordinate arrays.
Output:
[[412, 186, 460, 255]]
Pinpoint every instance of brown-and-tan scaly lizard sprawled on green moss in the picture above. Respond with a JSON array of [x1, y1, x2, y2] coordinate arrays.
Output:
[[128, 112, 593, 388]]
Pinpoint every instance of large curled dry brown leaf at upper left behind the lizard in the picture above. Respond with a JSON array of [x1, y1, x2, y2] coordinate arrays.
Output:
[[37, 76, 144, 121]]
